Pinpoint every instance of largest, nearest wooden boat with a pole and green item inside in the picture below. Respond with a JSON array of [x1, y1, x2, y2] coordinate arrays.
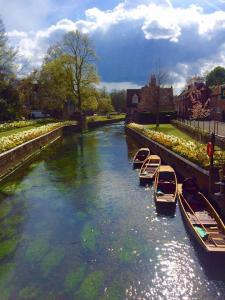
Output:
[[178, 191, 225, 253]]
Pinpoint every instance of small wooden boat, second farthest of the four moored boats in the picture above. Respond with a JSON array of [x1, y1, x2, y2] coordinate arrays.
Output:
[[139, 155, 161, 183]]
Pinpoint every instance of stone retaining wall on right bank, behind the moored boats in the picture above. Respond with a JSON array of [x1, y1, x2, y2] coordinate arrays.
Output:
[[126, 128, 209, 193]]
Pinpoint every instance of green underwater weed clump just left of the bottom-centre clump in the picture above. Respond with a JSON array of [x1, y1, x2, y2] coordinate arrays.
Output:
[[64, 265, 86, 292]]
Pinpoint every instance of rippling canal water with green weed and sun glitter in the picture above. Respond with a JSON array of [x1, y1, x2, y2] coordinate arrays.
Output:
[[0, 124, 225, 300]]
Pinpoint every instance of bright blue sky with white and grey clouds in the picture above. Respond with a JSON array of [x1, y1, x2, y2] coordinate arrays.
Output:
[[0, 0, 225, 93]]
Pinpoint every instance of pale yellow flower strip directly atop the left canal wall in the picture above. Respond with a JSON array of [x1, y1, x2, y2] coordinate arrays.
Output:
[[0, 121, 75, 153]]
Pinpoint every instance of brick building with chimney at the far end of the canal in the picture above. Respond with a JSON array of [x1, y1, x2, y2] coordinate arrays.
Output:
[[126, 75, 174, 122]]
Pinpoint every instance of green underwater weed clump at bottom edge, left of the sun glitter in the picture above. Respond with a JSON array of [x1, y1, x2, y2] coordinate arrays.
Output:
[[75, 271, 104, 300]]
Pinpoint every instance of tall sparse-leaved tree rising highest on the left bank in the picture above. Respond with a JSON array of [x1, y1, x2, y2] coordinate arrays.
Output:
[[46, 30, 99, 112]]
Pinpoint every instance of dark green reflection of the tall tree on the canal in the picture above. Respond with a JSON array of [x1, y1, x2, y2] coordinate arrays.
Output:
[[42, 132, 101, 212]]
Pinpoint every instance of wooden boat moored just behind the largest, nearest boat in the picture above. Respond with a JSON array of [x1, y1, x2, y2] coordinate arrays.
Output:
[[154, 165, 177, 204]]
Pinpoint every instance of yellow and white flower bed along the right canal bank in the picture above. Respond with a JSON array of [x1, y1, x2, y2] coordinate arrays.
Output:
[[127, 123, 209, 169]]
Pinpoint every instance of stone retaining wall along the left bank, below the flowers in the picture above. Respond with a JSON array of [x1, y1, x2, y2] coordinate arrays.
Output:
[[0, 125, 77, 180]]
